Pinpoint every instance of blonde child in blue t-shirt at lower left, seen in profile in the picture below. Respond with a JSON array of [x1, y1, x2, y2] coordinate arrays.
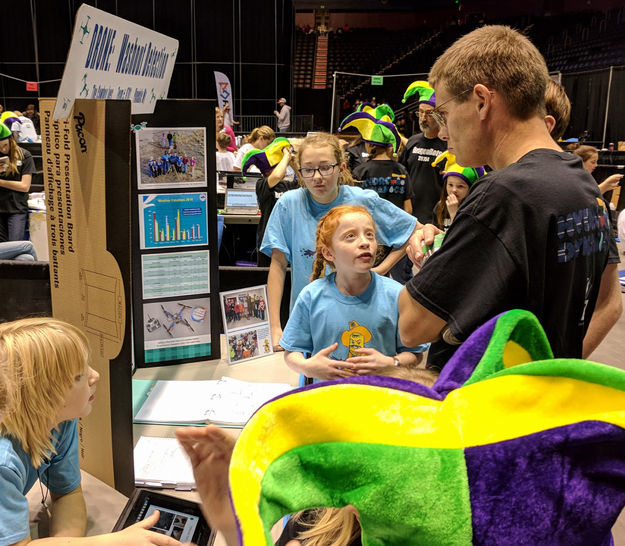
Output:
[[0, 317, 179, 546]]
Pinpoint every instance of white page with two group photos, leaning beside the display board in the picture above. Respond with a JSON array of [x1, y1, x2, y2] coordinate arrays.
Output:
[[220, 285, 273, 364]]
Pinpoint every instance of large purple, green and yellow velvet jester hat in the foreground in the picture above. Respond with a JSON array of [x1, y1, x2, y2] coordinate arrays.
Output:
[[229, 310, 625, 546]]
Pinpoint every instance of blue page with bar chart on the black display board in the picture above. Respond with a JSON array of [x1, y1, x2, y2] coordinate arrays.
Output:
[[138, 192, 208, 250]]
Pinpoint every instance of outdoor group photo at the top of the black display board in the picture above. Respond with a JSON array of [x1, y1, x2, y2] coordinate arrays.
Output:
[[135, 127, 207, 191]]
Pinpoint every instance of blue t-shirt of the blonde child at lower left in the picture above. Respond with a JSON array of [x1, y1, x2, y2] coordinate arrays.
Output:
[[0, 419, 80, 546]]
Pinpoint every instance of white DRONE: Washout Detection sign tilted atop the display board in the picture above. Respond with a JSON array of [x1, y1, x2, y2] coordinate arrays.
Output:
[[52, 4, 178, 119]]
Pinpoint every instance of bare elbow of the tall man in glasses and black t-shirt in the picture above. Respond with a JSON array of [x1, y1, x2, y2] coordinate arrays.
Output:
[[398, 287, 447, 347]]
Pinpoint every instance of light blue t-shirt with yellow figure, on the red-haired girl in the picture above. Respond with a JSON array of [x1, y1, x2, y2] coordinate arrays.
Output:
[[280, 272, 430, 360]]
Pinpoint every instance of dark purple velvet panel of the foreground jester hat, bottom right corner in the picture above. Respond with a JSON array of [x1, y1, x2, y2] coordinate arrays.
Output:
[[465, 421, 625, 546]]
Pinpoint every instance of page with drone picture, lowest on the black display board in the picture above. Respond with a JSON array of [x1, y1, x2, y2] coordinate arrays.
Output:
[[143, 297, 211, 363]]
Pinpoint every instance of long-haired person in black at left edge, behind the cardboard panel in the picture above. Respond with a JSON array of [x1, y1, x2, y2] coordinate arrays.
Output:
[[0, 123, 35, 242]]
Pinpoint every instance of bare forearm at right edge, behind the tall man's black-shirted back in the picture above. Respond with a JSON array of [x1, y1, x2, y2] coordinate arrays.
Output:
[[582, 264, 623, 358]]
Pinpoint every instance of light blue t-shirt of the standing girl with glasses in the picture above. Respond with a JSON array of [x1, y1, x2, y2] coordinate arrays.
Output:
[[260, 186, 417, 310]]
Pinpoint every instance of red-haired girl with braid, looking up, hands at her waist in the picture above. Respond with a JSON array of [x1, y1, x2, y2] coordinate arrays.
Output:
[[280, 205, 428, 379]]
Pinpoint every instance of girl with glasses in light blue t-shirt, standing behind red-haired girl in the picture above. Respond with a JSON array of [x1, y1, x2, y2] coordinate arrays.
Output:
[[260, 133, 420, 346]]
